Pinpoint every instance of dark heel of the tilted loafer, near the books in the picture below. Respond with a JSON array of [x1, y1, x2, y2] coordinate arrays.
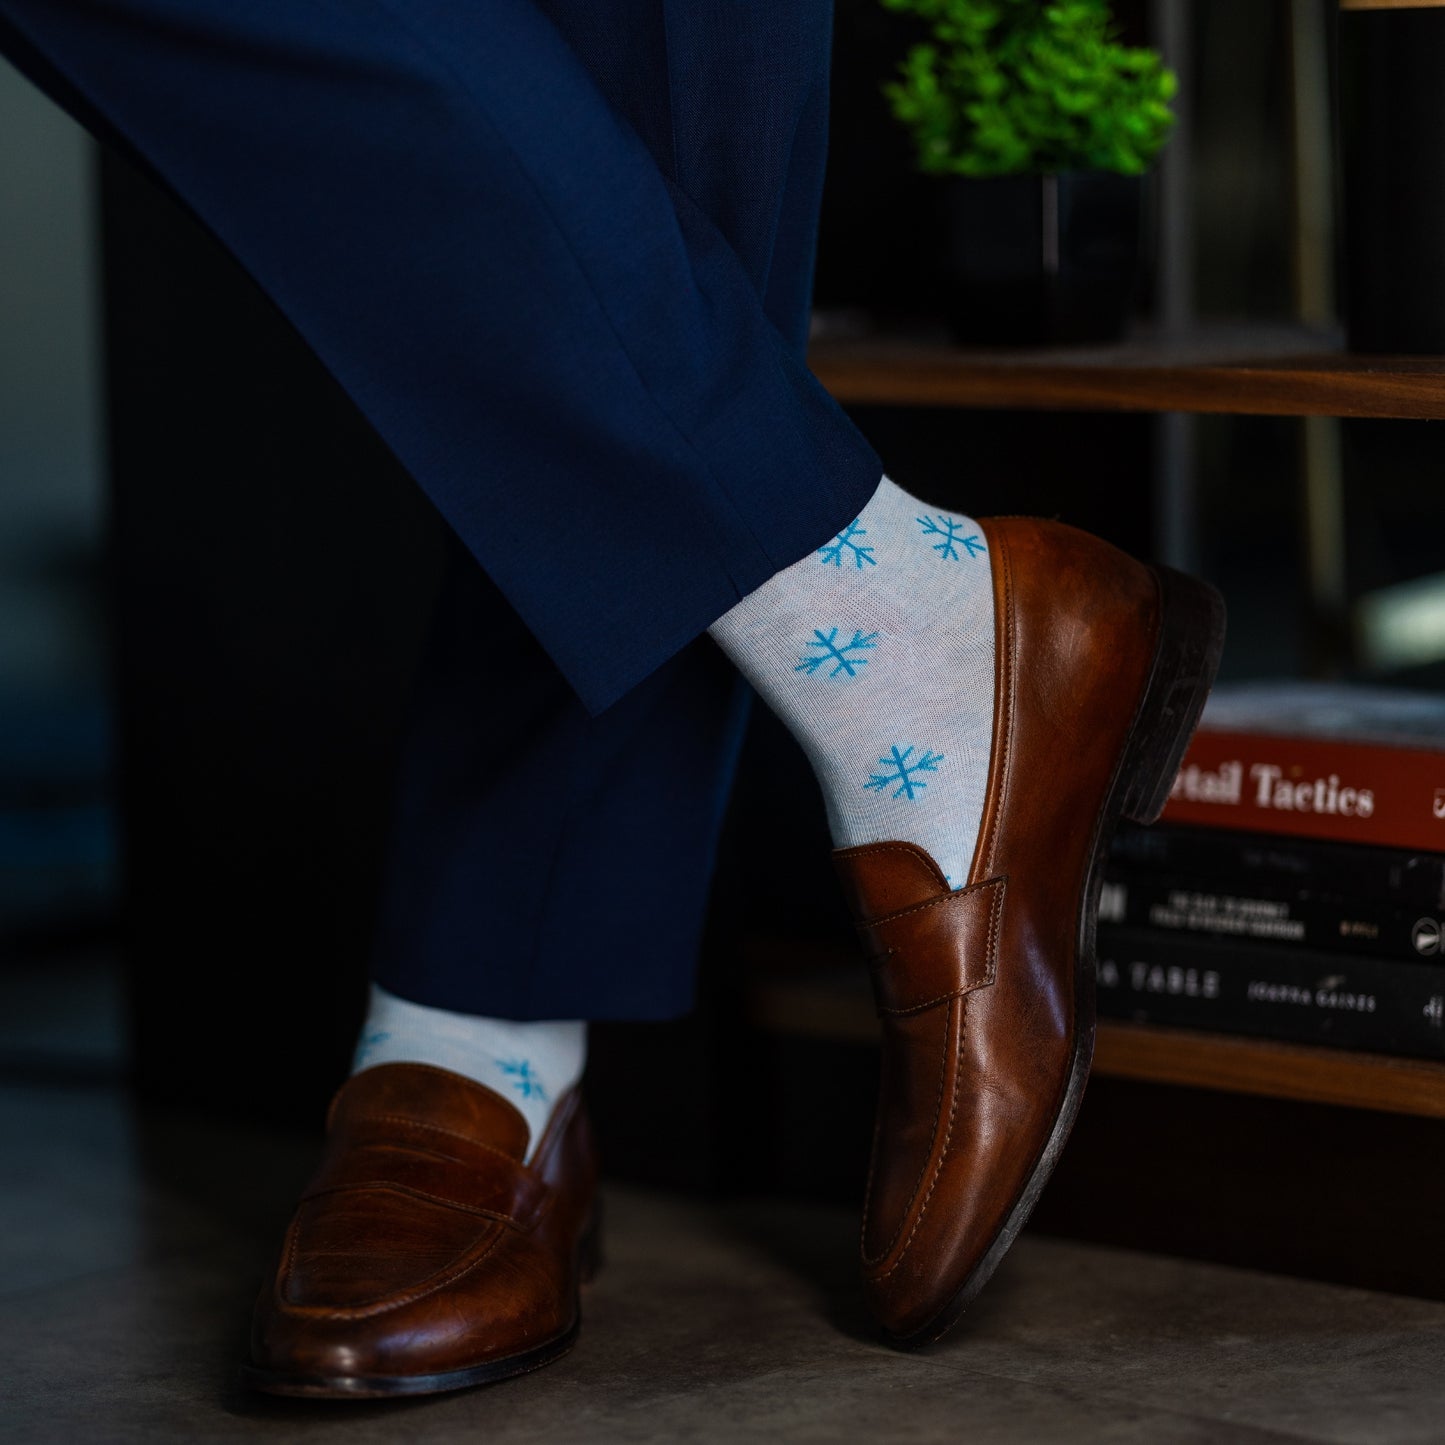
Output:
[[1120, 566, 1224, 822]]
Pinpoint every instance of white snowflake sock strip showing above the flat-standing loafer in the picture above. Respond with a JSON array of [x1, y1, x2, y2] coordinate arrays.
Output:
[[351, 984, 587, 1159]]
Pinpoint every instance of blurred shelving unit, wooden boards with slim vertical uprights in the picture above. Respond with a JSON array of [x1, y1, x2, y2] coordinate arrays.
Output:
[[786, 0, 1445, 1118]]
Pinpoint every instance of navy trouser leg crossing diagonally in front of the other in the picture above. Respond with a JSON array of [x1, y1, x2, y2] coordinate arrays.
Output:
[[0, 0, 881, 711]]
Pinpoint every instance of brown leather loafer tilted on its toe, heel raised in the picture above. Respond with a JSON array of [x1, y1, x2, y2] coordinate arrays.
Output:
[[835, 517, 1224, 1345]]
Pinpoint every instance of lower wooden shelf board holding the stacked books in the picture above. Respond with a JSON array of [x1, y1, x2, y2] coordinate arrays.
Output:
[[749, 944, 1445, 1118]]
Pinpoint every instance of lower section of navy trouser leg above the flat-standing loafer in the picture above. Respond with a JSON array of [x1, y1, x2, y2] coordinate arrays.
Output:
[[374, 556, 746, 1019]]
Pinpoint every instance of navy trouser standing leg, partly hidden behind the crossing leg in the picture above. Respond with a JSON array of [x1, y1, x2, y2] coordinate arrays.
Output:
[[364, 0, 831, 1019]]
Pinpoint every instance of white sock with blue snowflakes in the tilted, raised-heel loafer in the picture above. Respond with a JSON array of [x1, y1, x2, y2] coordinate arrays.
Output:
[[708, 477, 994, 889]]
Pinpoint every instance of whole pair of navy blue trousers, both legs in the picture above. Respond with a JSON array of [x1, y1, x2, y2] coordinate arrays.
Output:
[[0, 0, 881, 1019]]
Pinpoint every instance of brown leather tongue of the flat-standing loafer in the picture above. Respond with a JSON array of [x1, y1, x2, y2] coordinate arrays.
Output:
[[327, 1064, 532, 1160]]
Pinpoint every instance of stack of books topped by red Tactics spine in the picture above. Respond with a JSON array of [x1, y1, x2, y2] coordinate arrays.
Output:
[[1098, 683, 1445, 1058]]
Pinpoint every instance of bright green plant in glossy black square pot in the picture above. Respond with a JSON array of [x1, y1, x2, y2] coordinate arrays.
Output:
[[881, 0, 1176, 342]]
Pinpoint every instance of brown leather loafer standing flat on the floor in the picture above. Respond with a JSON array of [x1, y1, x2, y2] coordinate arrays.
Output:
[[244, 1064, 597, 1399]]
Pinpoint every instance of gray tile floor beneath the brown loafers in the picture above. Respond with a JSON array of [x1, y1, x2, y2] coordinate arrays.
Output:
[[0, 1087, 1445, 1445]]
